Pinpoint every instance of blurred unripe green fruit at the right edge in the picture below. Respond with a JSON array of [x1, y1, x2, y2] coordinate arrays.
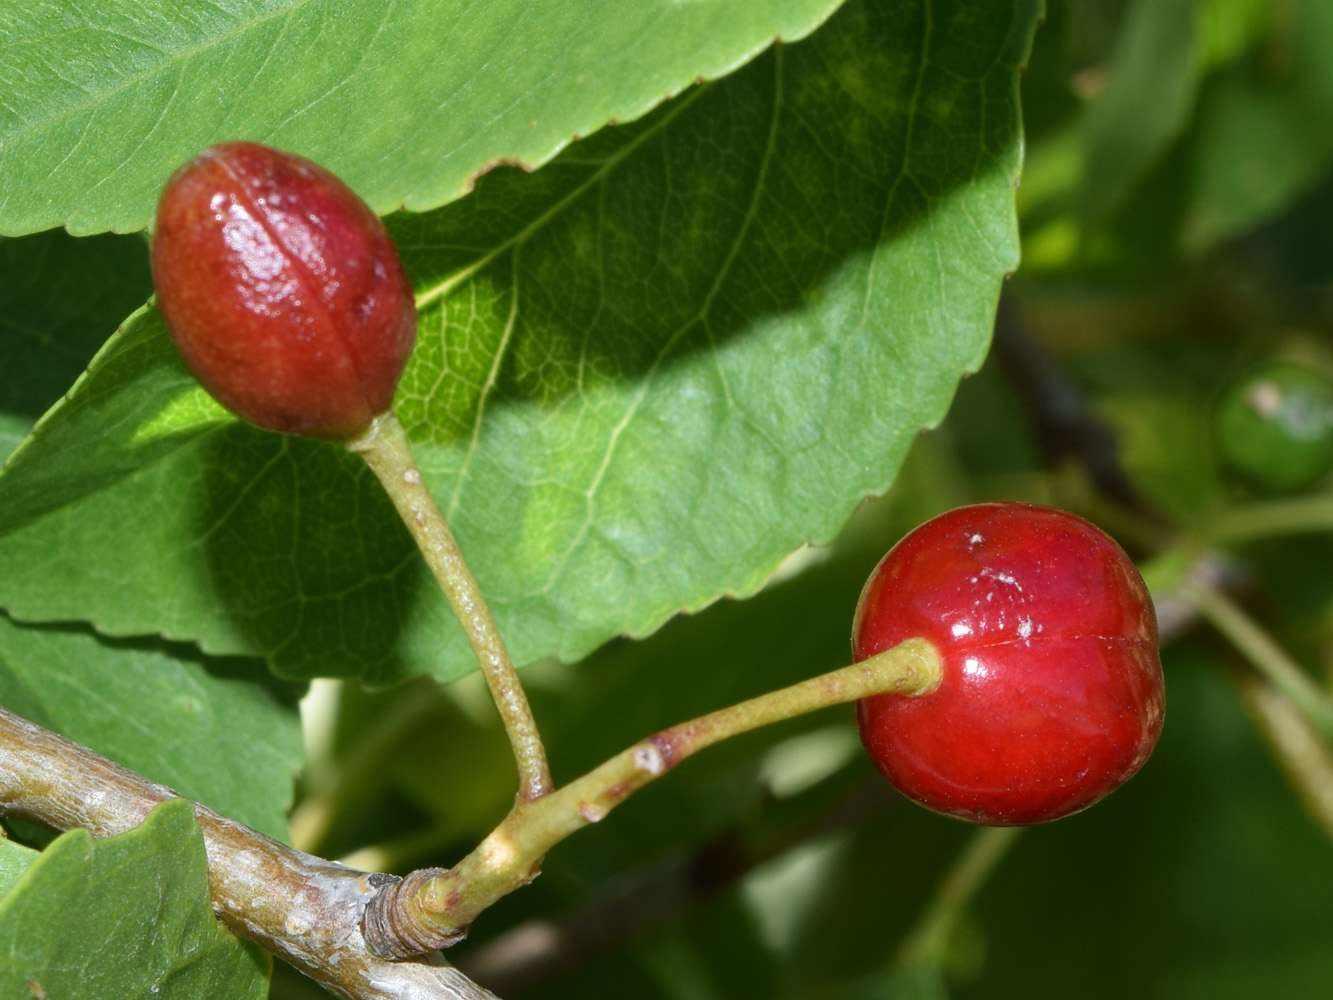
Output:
[[1214, 361, 1333, 493]]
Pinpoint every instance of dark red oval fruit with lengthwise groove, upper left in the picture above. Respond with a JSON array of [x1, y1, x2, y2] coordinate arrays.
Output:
[[152, 143, 416, 440]]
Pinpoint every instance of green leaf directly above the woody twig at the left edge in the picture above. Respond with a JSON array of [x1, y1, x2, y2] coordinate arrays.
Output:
[[0, 613, 301, 839]]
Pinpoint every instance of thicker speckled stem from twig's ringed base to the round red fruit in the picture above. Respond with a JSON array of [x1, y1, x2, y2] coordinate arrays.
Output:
[[364, 639, 941, 959]]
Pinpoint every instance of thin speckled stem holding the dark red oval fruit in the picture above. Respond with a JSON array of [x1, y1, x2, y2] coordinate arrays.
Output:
[[347, 409, 552, 803]]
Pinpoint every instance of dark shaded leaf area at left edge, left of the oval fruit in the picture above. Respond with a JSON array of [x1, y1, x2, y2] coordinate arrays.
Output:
[[0, 232, 152, 460]]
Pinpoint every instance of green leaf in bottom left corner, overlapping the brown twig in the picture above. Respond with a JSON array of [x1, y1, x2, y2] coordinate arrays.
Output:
[[0, 799, 271, 1000]]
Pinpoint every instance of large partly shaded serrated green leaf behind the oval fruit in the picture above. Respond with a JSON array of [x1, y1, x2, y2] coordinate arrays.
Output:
[[0, 0, 1037, 681]]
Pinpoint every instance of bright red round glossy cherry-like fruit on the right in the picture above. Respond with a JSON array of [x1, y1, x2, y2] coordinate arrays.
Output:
[[852, 503, 1164, 825]]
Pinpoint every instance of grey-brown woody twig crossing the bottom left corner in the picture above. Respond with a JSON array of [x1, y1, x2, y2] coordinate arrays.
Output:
[[0, 708, 495, 1000]]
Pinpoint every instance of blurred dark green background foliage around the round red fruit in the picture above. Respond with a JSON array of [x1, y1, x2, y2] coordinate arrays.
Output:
[[273, 0, 1333, 1000]]
